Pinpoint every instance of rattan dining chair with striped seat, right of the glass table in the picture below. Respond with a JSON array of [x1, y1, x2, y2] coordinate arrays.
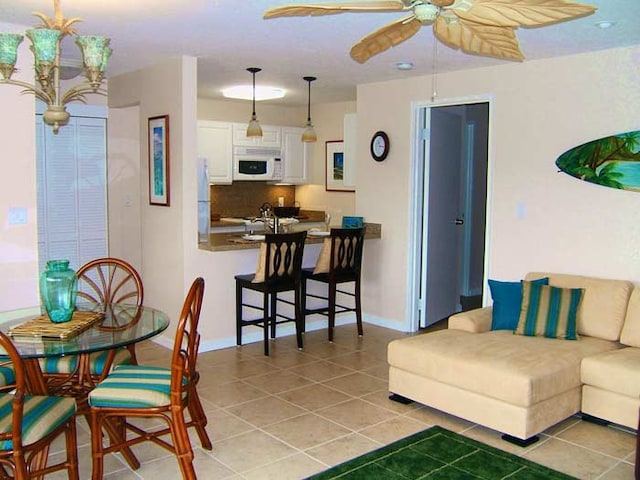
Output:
[[89, 278, 212, 480]]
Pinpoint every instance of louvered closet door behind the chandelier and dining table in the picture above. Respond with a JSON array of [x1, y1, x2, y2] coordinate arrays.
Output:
[[36, 115, 108, 271]]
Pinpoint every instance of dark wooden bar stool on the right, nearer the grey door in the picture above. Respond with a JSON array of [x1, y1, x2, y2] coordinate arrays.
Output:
[[300, 228, 364, 342]]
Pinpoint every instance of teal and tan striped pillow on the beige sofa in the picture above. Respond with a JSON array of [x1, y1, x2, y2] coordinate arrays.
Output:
[[514, 282, 584, 340]]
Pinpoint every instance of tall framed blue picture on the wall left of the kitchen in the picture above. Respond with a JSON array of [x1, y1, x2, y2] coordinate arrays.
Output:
[[149, 115, 170, 207]]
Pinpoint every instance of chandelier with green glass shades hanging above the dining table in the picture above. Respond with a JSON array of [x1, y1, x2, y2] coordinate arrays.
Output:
[[0, 0, 112, 133]]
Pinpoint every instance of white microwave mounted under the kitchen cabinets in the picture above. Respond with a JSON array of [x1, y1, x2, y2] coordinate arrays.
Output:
[[233, 147, 284, 181]]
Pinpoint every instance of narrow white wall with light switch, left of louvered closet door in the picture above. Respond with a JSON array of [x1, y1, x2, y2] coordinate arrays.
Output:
[[0, 23, 40, 312]]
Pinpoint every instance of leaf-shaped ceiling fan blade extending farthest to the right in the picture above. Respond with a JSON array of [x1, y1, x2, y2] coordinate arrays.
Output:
[[451, 0, 596, 27]]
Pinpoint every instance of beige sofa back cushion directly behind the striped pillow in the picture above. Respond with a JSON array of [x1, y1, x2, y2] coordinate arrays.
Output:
[[525, 272, 633, 341]]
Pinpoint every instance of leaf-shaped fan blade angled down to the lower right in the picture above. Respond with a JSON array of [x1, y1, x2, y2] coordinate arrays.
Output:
[[433, 16, 524, 60]]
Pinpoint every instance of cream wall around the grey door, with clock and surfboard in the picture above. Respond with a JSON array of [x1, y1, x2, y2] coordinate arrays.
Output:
[[356, 46, 640, 325]]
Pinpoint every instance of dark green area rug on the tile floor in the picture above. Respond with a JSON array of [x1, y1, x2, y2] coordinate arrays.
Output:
[[307, 426, 575, 480]]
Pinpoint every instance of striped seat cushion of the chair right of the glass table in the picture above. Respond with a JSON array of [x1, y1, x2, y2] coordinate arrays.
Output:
[[89, 365, 184, 408]]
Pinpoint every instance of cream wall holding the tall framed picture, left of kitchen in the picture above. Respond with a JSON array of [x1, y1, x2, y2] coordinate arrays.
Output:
[[109, 57, 198, 343]]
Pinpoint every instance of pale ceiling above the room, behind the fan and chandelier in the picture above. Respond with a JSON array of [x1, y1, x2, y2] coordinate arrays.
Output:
[[0, 0, 640, 106]]
